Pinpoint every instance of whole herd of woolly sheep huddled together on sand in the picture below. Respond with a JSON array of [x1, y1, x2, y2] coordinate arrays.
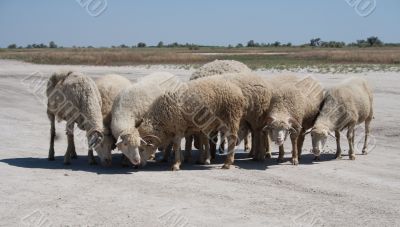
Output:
[[46, 60, 373, 170]]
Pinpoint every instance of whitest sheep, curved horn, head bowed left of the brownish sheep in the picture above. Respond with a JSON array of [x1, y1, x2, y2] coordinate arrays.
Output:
[[111, 72, 179, 165]]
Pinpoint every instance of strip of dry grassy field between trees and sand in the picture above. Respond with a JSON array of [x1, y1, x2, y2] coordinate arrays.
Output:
[[0, 47, 400, 69]]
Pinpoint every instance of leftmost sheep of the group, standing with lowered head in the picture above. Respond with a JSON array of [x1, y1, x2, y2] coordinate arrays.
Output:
[[46, 72, 107, 165]]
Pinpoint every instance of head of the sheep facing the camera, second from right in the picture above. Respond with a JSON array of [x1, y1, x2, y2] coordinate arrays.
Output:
[[263, 116, 301, 146]]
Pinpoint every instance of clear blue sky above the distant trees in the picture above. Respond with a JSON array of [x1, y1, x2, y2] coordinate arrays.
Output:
[[0, 0, 400, 47]]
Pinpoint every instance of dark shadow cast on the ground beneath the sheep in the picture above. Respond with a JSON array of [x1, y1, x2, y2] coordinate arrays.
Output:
[[0, 151, 335, 174]]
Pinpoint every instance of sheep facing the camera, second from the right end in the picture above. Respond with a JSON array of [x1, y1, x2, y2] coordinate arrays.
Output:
[[265, 77, 323, 165]]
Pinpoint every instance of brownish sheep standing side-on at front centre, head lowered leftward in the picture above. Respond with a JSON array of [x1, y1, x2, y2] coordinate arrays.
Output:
[[136, 78, 245, 170]]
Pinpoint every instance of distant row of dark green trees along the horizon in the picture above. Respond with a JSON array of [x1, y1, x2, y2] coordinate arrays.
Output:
[[8, 36, 400, 50]]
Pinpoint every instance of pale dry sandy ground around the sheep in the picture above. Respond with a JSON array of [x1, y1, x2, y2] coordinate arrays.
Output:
[[0, 60, 400, 227]]
